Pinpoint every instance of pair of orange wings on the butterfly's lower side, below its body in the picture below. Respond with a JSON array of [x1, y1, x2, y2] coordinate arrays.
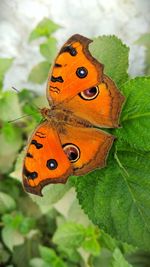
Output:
[[23, 121, 114, 196]]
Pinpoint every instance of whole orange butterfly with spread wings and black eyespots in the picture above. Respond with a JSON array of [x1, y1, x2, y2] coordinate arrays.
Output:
[[23, 34, 125, 196]]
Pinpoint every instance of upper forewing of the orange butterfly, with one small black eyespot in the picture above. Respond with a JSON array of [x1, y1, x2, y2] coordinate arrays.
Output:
[[47, 34, 103, 105]]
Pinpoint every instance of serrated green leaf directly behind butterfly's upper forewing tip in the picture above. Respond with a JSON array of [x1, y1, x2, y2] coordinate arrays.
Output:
[[90, 36, 129, 86]]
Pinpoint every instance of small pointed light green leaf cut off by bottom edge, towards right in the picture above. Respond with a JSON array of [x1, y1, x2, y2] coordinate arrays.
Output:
[[110, 248, 132, 267]]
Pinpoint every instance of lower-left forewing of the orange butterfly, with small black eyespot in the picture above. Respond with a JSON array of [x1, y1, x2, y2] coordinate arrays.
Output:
[[23, 121, 73, 195]]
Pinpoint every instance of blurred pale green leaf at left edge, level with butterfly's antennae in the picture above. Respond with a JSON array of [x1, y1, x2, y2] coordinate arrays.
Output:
[[0, 91, 22, 122]]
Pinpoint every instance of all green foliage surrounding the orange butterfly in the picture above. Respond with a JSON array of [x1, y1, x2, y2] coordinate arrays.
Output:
[[0, 19, 150, 267]]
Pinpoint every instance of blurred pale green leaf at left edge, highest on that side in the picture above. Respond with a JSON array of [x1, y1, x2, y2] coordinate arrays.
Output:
[[0, 58, 13, 90]]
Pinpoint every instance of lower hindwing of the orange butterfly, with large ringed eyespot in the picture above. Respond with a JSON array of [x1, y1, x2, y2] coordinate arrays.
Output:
[[59, 125, 114, 175]]
